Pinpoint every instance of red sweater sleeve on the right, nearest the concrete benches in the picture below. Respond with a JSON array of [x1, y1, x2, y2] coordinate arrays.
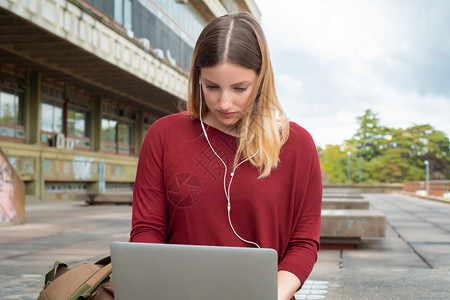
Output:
[[278, 136, 322, 285]]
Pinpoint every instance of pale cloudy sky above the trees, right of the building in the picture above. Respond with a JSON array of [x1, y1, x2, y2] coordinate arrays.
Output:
[[255, 0, 450, 147]]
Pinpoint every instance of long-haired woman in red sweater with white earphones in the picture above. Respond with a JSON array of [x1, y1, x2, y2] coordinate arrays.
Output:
[[131, 13, 322, 299]]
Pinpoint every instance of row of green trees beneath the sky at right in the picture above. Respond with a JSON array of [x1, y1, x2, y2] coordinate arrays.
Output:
[[320, 109, 450, 183]]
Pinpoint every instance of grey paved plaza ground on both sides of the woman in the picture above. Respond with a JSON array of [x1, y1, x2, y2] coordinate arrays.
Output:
[[0, 194, 450, 300]]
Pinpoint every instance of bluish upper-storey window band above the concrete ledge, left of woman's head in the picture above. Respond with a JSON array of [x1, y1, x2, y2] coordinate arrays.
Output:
[[85, 0, 206, 72]]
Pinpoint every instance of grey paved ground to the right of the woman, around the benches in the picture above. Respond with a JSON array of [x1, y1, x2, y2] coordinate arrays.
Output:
[[308, 194, 450, 299]]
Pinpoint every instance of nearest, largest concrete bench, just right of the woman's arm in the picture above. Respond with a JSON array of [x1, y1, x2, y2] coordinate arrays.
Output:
[[320, 209, 386, 243]]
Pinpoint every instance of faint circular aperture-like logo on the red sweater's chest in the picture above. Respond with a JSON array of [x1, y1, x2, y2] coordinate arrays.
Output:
[[167, 173, 202, 208]]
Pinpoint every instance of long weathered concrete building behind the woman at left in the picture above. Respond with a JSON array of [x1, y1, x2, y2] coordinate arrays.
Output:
[[0, 0, 260, 199]]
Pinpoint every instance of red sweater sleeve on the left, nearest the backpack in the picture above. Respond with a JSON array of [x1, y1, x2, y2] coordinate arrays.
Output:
[[130, 123, 168, 243]]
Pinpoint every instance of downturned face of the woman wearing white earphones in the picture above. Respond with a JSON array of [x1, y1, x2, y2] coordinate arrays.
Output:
[[200, 62, 258, 135]]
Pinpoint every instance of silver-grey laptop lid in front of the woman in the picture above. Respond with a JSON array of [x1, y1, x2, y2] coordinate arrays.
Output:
[[111, 242, 277, 300]]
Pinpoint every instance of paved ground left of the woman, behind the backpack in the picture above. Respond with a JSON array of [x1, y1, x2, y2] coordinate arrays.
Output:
[[0, 201, 131, 299]]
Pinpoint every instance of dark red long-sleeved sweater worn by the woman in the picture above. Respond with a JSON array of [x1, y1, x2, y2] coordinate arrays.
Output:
[[131, 113, 322, 284]]
